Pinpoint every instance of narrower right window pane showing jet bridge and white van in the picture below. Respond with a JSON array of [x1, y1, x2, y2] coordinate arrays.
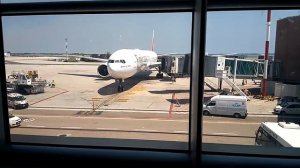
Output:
[[203, 10, 300, 152]]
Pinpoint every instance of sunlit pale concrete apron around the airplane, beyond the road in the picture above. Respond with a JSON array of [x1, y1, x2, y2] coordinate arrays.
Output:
[[5, 57, 277, 115]]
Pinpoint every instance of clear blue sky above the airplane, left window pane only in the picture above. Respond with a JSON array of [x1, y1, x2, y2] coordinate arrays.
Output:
[[3, 13, 192, 53]]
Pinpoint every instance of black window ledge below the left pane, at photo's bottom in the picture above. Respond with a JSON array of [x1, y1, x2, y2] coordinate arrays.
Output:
[[1, 144, 190, 167]]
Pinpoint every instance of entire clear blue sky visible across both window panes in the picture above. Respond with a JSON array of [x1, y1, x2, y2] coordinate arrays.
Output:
[[3, 10, 299, 54]]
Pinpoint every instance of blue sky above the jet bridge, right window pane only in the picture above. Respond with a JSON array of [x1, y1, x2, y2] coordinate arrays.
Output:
[[206, 10, 300, 53]]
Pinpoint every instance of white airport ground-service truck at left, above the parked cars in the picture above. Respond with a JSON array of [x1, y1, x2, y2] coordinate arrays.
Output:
[[6, 71, 47, 94]]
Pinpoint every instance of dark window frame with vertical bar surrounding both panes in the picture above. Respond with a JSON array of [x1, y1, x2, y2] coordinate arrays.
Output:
[[0, 0, 300, 167]]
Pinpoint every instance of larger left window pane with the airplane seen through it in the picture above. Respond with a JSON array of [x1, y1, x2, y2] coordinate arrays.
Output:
[[2, 12, 192, 151]]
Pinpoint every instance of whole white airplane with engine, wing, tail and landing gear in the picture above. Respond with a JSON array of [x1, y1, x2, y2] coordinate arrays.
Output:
[[83, 31, 163, 92]]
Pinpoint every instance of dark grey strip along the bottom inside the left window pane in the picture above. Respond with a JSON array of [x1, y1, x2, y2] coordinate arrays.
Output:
[[11, 134, 188, 151]]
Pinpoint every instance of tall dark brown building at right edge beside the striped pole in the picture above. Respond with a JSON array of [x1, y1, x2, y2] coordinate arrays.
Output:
[[274, 16, 300, 84]]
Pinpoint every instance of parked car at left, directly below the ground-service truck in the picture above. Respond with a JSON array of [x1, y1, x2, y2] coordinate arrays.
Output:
[[7, 93, 28, 109]]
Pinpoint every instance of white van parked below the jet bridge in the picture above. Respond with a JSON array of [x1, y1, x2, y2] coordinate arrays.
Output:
[[203, 95, 248, 118]]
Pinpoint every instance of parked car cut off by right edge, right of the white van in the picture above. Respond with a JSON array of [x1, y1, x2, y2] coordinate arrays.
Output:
[[274, 102, 300, 115]]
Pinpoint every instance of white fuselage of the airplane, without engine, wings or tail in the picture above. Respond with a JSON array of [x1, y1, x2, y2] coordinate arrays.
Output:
[[107, 49, 157, 79]]
